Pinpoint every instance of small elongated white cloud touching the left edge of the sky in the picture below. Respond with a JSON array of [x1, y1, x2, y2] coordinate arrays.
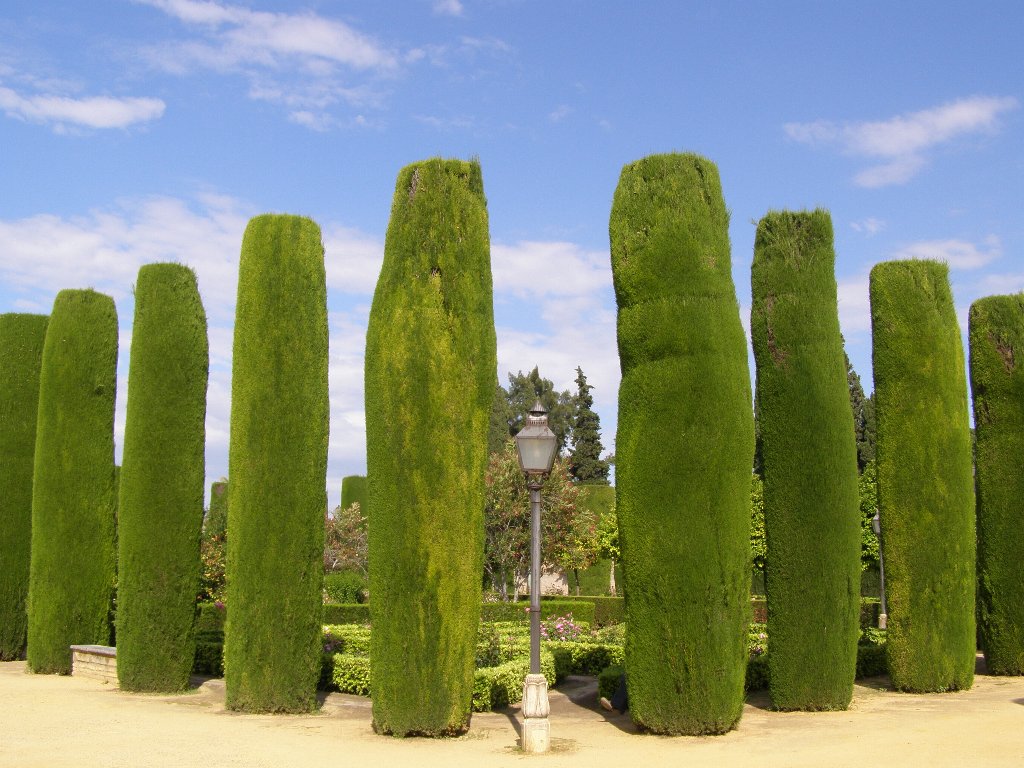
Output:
[[0, 86, 166, 130]]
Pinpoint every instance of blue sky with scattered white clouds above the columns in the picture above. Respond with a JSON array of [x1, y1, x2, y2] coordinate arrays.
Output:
[[0, 0, 1024, 506]]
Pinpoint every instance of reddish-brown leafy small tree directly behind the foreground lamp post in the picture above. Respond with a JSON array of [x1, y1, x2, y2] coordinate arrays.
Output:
[[484, 440, 597, 600]]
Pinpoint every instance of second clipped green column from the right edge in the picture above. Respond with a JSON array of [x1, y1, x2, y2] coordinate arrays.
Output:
[[870, 260, 975, 691]]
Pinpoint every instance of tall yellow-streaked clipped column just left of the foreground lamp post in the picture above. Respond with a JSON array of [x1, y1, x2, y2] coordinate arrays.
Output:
[[366, 159, 498, 735]]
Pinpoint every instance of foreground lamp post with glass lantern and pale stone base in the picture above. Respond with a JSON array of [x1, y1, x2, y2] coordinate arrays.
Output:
[[515, 399, 558, 753]]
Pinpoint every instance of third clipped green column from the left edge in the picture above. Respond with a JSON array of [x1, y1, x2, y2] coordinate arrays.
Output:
[[118, 264, 209, 691]]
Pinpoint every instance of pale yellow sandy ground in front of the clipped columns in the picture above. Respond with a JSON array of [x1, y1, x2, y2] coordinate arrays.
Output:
[[0, 662, 1024, 768]]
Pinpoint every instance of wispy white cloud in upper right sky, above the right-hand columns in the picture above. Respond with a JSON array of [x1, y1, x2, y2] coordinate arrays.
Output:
[[783, 96, 1018, 187]]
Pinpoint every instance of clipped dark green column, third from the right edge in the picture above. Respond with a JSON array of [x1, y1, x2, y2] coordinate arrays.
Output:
[[751, 210, 860, 710]]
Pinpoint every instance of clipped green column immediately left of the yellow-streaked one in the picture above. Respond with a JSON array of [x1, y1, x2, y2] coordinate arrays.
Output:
[[224, 215, 330, 712]]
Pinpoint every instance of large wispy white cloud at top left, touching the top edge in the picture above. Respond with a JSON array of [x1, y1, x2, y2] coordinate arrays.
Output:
[[135, 0, 400, 130]]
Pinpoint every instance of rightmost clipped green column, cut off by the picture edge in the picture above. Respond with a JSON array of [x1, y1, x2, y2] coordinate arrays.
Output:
[[969, 294, 1024, 675]]
